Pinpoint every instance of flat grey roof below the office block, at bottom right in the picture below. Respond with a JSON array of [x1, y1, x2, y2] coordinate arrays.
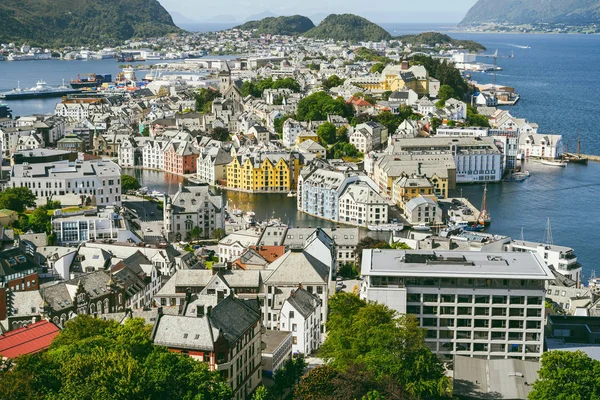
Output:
[[453, 356, 540, 400]]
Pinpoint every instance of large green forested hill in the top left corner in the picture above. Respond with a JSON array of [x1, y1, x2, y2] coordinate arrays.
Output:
[[0, 0, 180, 47]]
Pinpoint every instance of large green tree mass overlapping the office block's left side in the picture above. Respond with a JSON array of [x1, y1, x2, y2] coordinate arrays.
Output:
[[319, 293, 451, 399]]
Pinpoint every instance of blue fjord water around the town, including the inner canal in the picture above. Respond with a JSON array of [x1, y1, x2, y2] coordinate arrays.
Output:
[[0, 28, 600, 277]]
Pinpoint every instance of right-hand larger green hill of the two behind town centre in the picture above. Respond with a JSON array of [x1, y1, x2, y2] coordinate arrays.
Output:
[[304, 14, 392, 42]]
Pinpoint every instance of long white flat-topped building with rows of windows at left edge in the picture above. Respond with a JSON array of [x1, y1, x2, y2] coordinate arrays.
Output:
[[9, 160, 121, 207]]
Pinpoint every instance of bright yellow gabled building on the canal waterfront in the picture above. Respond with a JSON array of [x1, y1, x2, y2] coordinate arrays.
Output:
[[227, 152, 300, 193]]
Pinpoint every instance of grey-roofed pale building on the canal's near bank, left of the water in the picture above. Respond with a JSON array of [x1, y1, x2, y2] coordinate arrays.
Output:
[[163, 183, 225, 241]]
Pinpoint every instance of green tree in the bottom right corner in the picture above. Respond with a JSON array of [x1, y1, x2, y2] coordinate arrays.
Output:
[[528, 351, 600, 400]]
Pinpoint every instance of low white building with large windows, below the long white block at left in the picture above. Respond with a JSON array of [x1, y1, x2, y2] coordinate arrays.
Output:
[[52, 206, 141, 246]]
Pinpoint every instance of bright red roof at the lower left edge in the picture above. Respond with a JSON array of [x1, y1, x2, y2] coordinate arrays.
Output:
[[0, 320, 59, 358]]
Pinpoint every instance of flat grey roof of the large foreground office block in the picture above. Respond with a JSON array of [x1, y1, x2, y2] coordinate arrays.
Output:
[[361, 249, 554, 280]]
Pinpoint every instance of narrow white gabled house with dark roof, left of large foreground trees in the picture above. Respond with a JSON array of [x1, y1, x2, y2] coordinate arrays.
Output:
[[279, 285, 322, 355]]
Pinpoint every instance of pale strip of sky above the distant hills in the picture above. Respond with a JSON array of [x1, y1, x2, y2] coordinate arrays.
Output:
[[159, 0, 477, 23]]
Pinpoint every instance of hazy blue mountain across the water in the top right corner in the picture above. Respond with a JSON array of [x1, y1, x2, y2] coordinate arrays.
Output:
[[460, 0, 600, 25]]
